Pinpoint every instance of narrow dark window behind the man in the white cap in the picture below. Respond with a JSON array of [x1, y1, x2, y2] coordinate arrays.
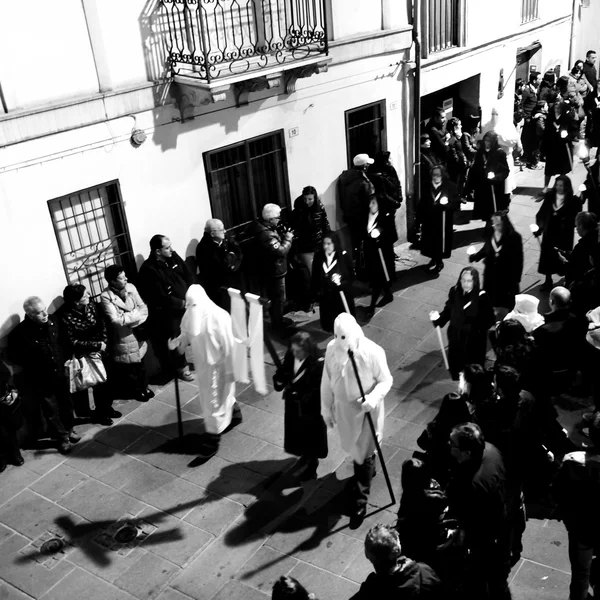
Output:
[[346, 100, 387, 167]]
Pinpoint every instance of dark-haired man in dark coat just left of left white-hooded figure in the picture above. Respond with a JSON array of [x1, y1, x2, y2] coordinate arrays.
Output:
[[139, 234, 194, 381]]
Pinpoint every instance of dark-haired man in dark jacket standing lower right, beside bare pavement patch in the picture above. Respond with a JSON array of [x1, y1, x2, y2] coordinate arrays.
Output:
[[447, 423, 510, 600]]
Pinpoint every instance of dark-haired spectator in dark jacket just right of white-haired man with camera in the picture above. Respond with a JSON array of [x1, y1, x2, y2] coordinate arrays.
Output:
[[292, 185, 331, 273]]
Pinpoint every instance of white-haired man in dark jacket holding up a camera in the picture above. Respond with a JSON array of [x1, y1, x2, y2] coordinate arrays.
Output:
[[248, 204, 294, 330]]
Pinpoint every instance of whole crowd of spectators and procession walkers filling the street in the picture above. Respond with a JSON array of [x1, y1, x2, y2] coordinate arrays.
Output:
[[0, 51, 600, 600]]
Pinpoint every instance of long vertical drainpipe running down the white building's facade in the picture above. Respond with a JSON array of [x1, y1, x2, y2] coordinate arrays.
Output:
[[406, 0, 421, 242]]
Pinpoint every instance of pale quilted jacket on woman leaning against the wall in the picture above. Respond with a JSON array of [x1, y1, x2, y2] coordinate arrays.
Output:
[[100, 283, 148, 363]]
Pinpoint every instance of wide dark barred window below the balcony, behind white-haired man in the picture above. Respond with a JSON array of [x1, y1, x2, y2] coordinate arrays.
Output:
[[204, 130, 290, 229]]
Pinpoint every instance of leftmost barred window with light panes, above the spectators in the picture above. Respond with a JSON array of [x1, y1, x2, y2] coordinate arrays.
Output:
[[48, 182, 136, 298]]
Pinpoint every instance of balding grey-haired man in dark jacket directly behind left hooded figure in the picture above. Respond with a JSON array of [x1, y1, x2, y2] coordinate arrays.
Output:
[[196, 219, 243, 312]]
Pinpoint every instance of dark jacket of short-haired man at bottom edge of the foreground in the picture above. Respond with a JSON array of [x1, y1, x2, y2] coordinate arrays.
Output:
[[351, 559, 444, 600]]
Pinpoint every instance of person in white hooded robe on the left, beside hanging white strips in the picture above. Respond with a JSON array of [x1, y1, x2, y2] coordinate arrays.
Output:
[[169, 284, 242, 457]]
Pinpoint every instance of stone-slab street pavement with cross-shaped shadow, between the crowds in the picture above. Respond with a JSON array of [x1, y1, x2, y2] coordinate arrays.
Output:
[[0, 162, 584, 600]]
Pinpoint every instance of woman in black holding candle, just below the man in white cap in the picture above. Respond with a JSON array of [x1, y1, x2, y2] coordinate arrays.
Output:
[[363, 198, 398, 315]]
